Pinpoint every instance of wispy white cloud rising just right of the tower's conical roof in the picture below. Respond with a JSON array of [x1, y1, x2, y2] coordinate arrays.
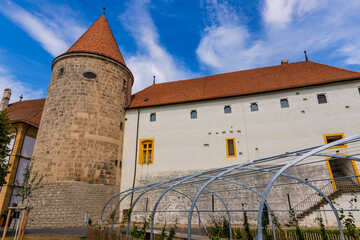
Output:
[[120, 0, 192, 92]]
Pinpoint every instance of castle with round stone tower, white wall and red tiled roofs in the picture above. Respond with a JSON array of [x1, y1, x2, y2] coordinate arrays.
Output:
[[0, 16, 360, 227]]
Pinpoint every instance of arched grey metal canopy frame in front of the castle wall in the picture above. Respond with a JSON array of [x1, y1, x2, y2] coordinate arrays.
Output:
[[100, 134, 360, 240]]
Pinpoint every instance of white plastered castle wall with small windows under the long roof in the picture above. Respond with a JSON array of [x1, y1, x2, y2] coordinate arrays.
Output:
[[121, 80, 360, 226]]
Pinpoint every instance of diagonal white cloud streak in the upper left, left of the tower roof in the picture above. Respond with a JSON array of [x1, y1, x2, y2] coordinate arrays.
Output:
[[0, 1, 85, 57]]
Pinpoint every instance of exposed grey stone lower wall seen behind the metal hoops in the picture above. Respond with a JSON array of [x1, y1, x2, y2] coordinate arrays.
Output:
[[121, 163, 329, 225]]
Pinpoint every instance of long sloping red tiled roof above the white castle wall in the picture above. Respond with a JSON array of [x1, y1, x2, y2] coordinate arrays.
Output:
[[128, 61, 360, 108]]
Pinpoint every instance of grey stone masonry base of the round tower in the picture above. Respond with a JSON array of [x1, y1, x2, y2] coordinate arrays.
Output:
[[28, 182, 118, 228]]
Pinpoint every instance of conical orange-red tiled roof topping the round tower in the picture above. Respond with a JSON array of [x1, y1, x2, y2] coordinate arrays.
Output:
[[65, 15, 125, 65]]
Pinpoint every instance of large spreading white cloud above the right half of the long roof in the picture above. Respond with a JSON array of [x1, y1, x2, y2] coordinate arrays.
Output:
[[196, 0, 360, 73]]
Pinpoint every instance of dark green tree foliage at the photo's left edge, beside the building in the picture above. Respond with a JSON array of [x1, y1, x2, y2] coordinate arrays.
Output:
[[0, 109, 13, 186]]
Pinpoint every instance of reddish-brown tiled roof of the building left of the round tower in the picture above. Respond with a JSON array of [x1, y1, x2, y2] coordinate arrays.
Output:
[[7, 98, 45, 128]]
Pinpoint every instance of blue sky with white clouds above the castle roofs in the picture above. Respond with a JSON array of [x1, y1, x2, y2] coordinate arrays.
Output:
[[0, 0, 360, 102]]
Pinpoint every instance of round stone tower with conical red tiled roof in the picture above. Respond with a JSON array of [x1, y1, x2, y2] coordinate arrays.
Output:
[[29, 16, 133, 227]]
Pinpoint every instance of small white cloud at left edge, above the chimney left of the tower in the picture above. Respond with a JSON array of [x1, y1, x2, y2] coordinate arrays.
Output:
[[0, 65, 44, 102]]
